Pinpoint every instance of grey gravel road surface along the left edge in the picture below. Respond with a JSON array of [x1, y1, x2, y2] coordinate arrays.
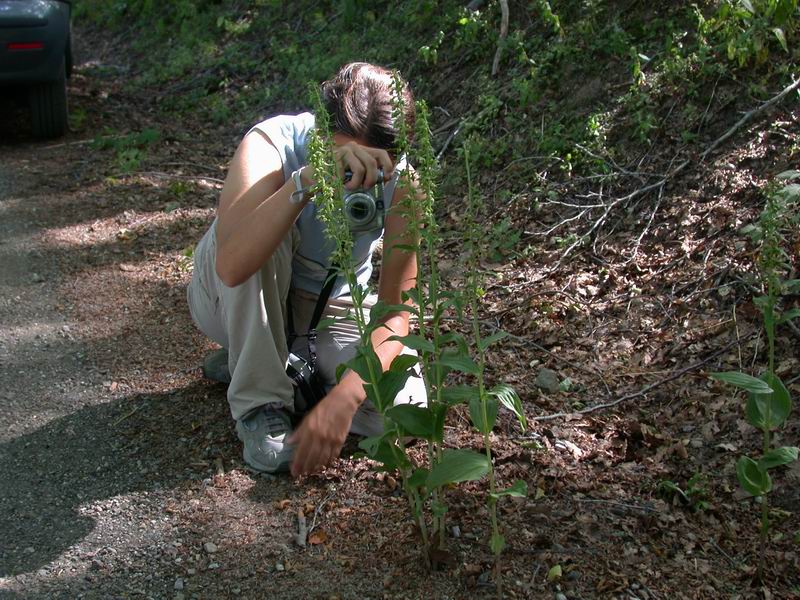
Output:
[[0, 139, 182, 598]]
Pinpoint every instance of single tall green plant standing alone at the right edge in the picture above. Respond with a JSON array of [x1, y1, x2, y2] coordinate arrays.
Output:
[[711, 171, 800, 578]]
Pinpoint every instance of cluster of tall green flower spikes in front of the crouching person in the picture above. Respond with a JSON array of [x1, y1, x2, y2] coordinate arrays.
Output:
[[309, 74, 524, 580]]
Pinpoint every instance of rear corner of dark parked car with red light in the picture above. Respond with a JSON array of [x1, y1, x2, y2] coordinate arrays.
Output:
[[0, 0, 72, 138]]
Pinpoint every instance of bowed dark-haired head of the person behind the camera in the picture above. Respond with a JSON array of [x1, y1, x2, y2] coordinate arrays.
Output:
[[322, 63, 416, 151]]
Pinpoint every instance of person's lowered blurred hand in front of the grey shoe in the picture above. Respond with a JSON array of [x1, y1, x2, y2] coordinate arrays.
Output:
[[288, 386, 358, 477]]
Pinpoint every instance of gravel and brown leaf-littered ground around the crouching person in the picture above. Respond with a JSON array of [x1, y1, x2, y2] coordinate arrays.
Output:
[[0, 25, 800, 600]]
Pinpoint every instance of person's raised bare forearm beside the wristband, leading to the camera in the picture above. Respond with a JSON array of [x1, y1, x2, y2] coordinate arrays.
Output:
[[216, 179, 308, 287]]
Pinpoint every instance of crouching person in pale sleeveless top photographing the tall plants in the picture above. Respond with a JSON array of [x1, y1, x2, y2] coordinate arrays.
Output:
[[188, 63, 427, 475]]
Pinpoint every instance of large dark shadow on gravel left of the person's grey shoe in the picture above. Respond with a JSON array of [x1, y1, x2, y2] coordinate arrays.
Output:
[[0, 381, 234, 576]]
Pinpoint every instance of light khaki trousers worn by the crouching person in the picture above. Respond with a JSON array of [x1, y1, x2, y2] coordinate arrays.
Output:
[[187, 221, 427, 435]]
